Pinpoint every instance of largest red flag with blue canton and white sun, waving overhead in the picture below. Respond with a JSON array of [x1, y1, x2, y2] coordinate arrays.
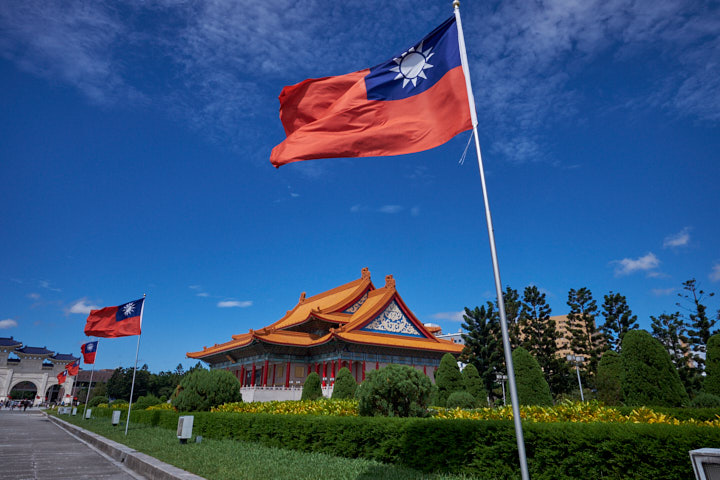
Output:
[[270, 16, 472, 167]]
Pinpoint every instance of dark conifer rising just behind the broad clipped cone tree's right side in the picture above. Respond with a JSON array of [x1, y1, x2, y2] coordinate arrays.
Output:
[[650, 312, 700, 392]]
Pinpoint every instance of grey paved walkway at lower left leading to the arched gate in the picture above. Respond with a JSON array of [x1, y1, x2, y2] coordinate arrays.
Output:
[[0, 408, 145, 480]]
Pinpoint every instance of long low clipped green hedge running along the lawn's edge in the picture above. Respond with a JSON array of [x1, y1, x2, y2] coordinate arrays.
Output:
[[87, 409, 720, 480]]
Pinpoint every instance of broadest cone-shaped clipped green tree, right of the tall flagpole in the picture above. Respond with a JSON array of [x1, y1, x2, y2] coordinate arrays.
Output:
[[620, 330, 689, 407]]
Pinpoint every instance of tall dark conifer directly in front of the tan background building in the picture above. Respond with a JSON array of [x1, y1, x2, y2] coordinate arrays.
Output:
[[567, 287, 600, 376]]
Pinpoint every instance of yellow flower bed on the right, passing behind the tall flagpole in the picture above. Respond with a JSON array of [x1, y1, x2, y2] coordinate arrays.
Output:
[[433, 401, 720, 427]]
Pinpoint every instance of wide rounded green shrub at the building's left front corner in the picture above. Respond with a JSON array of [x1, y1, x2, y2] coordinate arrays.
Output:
[[172, 369, 242, 412]]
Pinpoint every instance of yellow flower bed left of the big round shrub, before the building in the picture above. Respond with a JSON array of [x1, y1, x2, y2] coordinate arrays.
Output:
[[212, 399, 358, 417]]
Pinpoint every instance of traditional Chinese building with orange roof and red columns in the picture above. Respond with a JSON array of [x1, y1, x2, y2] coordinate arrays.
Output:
[[187, 268, 463, 401]]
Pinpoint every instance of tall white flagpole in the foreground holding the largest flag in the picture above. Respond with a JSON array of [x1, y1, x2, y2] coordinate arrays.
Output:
[[453, 0, 530, 480]]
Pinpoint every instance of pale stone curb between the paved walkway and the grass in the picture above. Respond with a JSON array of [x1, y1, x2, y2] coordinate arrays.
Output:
[[43, 412, 205, 480]]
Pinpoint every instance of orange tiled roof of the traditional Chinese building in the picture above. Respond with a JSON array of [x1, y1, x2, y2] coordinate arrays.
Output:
[[187, 268, 463, 358]]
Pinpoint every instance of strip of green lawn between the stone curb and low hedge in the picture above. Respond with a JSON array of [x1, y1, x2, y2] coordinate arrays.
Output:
[[56, 415, 471, 480]]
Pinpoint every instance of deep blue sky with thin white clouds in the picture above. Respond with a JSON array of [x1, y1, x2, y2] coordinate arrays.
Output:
[[0, 0, 720, 371]]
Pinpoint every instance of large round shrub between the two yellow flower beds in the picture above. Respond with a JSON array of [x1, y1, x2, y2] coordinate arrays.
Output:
[[355, 364, 432, 417]]
